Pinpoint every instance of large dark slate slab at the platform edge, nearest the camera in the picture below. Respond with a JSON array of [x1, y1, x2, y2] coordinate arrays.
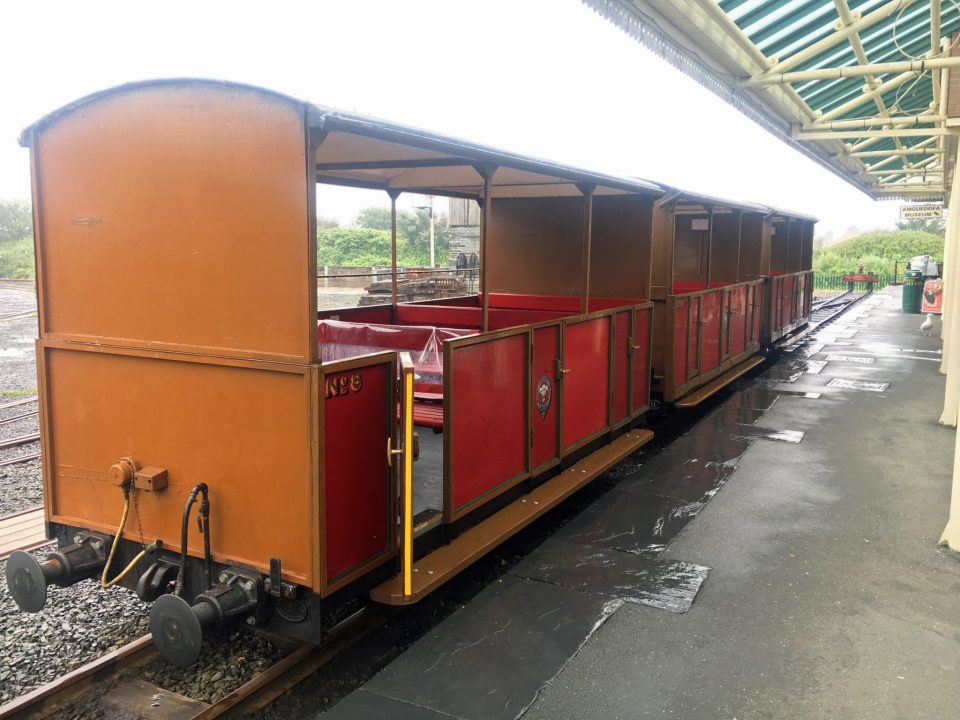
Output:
[[323, 575, 620, 720]]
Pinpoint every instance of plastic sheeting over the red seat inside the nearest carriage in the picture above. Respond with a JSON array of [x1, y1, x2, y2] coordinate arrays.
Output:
[[317, 320, 476, 396]]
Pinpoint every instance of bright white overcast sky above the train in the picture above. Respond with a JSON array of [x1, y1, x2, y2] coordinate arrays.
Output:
[[0, 0, 899, 234]]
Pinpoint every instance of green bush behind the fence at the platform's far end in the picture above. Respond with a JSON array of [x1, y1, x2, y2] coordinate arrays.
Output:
[[813, 230, 943, 275]]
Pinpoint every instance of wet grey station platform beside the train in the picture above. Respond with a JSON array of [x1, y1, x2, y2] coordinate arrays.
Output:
[[322, 288, 960, 720]]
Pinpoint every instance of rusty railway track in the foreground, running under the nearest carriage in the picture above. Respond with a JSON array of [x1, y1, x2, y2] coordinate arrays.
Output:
[[0, 607, 385, 720]]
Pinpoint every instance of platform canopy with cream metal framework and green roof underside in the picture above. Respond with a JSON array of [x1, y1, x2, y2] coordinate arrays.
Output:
[[583, 0, 960, 200]]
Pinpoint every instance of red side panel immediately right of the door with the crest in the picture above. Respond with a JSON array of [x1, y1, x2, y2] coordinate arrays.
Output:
[[561, 316, 610, 448]]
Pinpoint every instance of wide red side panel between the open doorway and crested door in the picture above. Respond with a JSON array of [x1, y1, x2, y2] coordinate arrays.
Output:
[[444, 330, 529, 522]]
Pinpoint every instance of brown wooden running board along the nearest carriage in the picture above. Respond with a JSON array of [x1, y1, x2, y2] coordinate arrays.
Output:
[[370, 430, 653, 605]]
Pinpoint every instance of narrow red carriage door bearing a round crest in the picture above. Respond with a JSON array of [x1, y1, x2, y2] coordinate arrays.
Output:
[[530, 323, 560, 469]]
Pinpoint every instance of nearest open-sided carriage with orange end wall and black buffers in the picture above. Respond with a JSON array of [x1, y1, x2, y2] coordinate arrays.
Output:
[[7, 80, 663, 664]]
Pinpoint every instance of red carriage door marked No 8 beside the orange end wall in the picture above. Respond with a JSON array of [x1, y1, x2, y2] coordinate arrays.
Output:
[[319, 352, 399, 595]]
